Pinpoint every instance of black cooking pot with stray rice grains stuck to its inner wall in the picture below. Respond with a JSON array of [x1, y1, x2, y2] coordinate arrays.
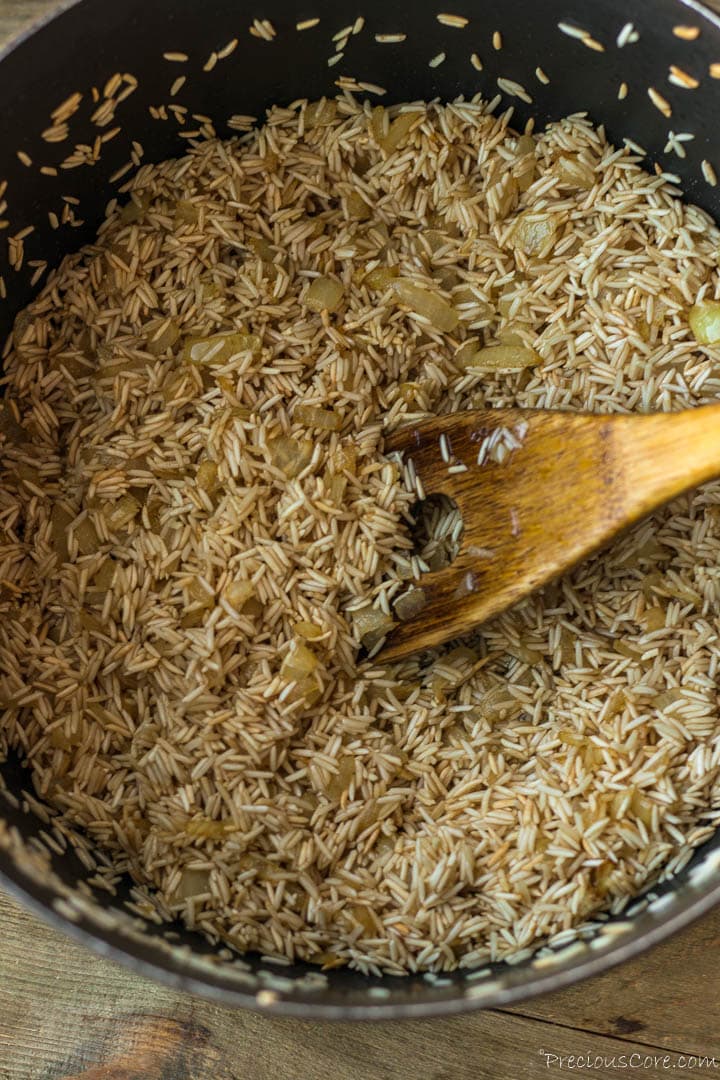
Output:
[[0, 0, 720, 1018]]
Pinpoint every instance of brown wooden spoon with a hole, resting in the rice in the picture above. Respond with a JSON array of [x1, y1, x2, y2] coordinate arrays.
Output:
[[379, 405, 720, 661]]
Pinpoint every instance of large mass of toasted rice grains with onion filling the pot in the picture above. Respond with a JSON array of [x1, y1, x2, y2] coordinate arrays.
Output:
[[0, 94, 720, 980]]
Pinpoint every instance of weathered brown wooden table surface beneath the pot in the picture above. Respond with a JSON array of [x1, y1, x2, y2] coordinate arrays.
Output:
[[0, 0, 720, 1080]]
